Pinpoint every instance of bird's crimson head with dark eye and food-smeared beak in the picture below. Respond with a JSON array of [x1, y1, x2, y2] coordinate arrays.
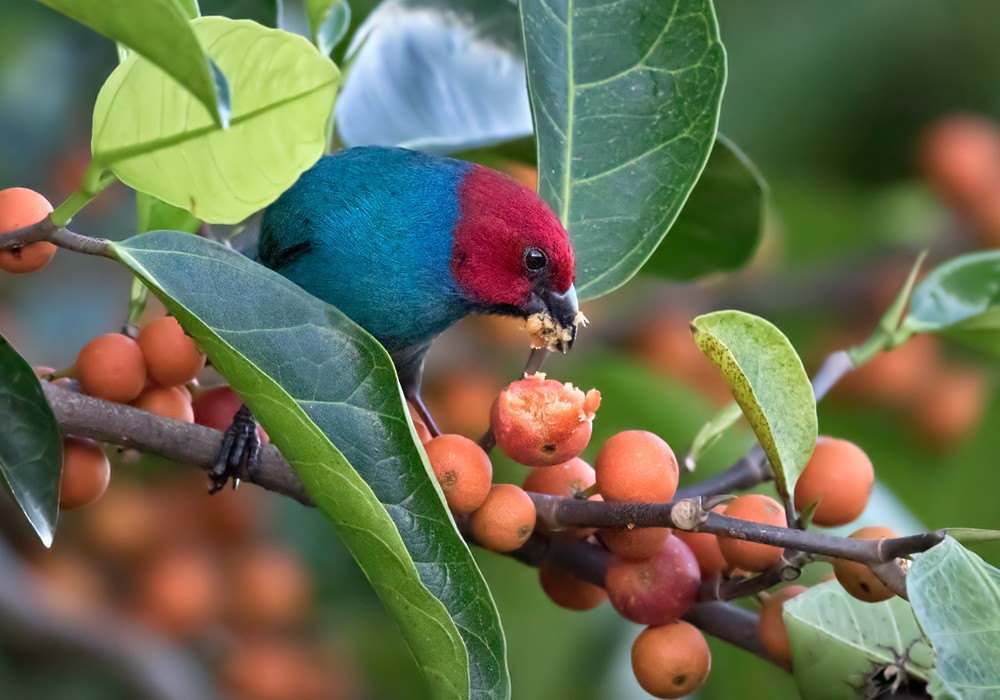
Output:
[[451, 165, 579, 351]]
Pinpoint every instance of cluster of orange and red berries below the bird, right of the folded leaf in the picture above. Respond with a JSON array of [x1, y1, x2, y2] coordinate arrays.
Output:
[[413, 374, 895, 698]]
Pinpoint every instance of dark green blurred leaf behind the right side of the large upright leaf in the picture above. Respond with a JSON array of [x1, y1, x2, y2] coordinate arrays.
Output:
[[642, 134, 767, 280]]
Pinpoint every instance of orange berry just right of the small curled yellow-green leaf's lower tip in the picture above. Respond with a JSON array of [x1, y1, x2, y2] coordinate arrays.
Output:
[[795, 436, 875, 527]]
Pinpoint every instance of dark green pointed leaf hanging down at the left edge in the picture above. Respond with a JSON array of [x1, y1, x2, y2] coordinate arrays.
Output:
[[0, 337, 62, 547]]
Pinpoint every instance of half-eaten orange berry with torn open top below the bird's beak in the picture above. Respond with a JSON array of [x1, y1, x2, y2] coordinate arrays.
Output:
[[491, 373, 601, 467]]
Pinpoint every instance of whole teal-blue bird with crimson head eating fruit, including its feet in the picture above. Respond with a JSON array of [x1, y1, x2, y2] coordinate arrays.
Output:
[[212, 146, 584, 490]]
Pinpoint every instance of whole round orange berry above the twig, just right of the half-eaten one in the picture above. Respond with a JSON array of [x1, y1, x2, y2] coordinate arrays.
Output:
[[594, 430, 678, 503]]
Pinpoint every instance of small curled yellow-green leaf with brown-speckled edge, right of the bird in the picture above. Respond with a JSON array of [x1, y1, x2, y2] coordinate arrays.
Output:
[[691, 311, 817, 500]]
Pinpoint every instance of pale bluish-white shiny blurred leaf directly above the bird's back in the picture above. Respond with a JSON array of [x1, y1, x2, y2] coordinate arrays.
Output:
[[337, 0, 531, 153]]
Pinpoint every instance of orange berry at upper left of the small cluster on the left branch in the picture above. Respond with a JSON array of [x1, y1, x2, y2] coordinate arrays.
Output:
[[73, 333, 146, 403]]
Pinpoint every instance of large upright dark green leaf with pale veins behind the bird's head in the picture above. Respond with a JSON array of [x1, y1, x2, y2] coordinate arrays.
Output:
[[520, 0, 726, 299]]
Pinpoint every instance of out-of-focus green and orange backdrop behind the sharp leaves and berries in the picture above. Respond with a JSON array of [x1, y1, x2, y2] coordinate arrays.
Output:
[[0, 0, 1000, 700]]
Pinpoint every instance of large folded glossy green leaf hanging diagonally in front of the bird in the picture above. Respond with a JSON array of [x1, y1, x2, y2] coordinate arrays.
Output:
[[113, 231, 509, 698]]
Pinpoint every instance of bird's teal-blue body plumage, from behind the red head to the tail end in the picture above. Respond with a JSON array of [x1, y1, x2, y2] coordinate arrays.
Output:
[[259, 147, 471, 352]]
